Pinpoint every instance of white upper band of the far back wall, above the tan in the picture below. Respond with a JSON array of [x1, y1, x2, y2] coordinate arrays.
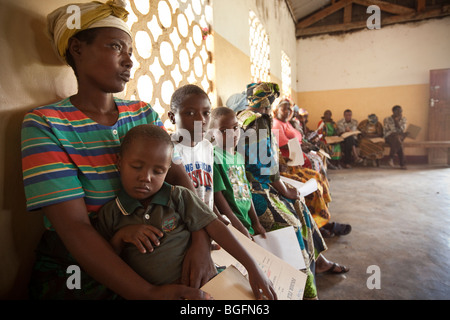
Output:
[[297, 17, 450, 92]]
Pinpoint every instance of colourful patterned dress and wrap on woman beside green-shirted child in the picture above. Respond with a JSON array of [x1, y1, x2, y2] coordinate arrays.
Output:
[[237, 109, 327, 298]]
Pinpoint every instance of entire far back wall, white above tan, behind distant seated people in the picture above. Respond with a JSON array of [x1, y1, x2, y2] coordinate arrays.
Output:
[[297, 17, 450, 155]]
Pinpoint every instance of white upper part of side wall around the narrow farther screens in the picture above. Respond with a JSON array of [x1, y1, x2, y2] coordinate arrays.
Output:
[[212, 0, 297, 86]]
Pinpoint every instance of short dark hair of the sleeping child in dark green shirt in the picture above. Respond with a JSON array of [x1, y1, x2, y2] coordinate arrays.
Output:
[[119, 124, 173, 156]]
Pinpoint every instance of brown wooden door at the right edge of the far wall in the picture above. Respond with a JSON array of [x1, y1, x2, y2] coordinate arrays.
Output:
[[428, 69, 450, 164]]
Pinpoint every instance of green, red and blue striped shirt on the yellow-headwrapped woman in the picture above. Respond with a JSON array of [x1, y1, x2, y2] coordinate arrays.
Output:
[[21, 98, 163, 228]]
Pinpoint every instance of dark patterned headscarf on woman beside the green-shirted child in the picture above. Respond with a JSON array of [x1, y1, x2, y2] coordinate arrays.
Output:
[[247, 82, 280, 109]]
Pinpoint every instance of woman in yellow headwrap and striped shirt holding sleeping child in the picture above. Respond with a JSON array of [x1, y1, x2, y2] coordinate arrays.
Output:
[[22, 1, 215, 299]]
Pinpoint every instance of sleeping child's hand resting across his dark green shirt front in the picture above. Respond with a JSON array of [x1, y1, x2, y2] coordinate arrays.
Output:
[[111, 224, 164, 253]]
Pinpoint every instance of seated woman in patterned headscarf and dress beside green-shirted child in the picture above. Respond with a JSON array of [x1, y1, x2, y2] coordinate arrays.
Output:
[[237, 82, 348, 299]]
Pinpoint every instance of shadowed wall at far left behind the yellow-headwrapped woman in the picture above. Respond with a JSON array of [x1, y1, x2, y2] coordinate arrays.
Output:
[[0, 0, 89, 298]]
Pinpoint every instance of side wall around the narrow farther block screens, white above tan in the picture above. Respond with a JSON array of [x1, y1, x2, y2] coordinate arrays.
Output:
[[213, 0, 297, 105]]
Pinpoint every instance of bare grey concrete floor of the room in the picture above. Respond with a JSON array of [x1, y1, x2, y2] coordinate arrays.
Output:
[[317, 165, 450, 300]]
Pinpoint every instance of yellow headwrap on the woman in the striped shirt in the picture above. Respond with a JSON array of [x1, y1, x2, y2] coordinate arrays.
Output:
[[47, 0, 132, 62]]
